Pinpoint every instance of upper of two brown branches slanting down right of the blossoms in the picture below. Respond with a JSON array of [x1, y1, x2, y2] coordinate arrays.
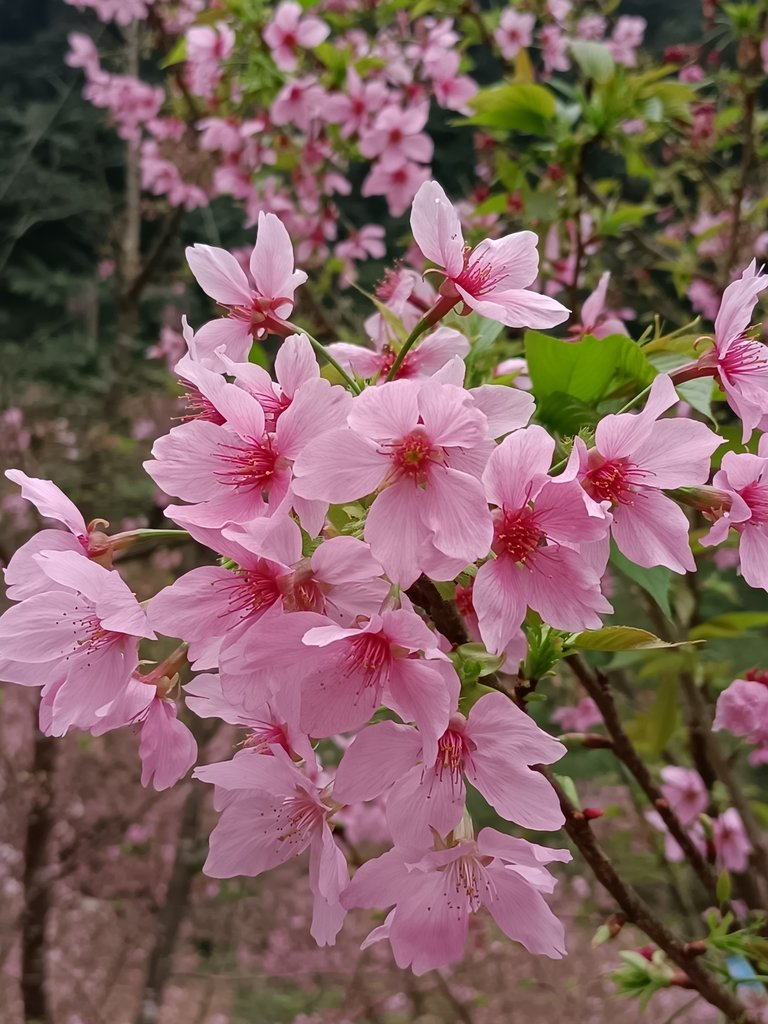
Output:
[[565, 654, 718, 902]]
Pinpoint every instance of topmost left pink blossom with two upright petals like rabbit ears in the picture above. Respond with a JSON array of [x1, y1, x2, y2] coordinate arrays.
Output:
[[186, 213, 306, 360]]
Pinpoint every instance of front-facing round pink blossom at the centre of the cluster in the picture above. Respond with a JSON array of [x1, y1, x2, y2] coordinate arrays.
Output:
[[294, 380, 492, 587]]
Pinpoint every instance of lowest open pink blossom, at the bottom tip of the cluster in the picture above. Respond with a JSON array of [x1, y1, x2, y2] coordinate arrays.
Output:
[[341, 828, 570, 975]]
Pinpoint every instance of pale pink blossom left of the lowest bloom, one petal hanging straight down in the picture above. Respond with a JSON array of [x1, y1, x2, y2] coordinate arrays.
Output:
[[195, 745, 348, 945]]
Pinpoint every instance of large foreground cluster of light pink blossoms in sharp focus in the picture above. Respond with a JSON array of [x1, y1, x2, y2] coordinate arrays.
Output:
[[0, 182, 768, 974]]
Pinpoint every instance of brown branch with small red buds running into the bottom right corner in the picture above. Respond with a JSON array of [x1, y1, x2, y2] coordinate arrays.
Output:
[[539, 768, 757, 1024]]
